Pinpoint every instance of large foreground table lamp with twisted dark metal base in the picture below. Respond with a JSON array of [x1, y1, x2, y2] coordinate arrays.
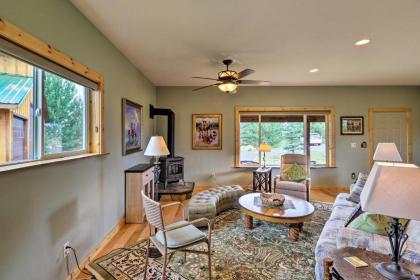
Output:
[[360, 162, 420, 280]]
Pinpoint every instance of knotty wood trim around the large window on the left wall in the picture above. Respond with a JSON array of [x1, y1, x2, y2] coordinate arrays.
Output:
[[0, 18, 106, 172]]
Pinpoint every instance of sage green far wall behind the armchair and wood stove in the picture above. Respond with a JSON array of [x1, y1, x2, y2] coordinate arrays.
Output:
[[157, 87, 420, 187]]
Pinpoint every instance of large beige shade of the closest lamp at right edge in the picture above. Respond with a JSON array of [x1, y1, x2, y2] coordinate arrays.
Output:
[[360, 162, 420, 221]]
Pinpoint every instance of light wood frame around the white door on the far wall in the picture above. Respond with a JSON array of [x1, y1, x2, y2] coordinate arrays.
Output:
[[368, 107, 413, 167]]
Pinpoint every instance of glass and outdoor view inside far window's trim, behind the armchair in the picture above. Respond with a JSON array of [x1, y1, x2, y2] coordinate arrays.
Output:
[[239, 114, 327, 166]]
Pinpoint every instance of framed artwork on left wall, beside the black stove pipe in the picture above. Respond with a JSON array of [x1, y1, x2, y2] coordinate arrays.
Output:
[[122, 98, 143, 155]]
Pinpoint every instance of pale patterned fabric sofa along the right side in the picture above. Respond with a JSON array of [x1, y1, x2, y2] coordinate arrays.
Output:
[[315, 189, 420, 280]]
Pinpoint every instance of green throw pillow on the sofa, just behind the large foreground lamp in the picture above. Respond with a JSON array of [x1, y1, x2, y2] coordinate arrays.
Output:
[[347, 212, 408, 235]]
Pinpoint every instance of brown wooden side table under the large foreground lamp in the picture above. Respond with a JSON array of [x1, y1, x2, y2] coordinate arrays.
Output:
[[323, 247, 420, 280]]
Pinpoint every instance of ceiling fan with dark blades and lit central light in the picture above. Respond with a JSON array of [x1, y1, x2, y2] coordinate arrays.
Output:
[[193, 59, 270, 94]]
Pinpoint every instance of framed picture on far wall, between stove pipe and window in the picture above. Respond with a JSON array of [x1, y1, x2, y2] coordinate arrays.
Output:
[[192, 114, 222, 150]]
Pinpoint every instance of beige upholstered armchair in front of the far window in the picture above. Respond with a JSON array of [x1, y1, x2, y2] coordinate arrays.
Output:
[[274, 154, 311, 201]]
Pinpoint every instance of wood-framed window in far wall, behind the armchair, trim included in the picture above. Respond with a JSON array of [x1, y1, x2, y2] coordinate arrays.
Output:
[[235, 107, 335, 167]]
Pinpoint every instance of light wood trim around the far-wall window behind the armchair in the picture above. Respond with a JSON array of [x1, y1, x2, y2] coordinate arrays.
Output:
[[234, 106, 336, 168]]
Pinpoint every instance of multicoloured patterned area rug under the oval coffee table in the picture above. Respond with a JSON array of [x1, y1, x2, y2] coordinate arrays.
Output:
[[88, 202, 331, 280]]
